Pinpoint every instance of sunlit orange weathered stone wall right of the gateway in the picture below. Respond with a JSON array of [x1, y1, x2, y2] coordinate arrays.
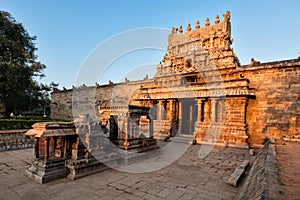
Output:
[[235, 59, 300, 145]]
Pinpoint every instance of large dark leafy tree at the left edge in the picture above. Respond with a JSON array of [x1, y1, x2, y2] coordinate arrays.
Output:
[[0, 11, 55, 117]]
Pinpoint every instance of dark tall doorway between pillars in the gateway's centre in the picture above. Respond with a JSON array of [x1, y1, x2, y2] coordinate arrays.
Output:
[[179, 99, 198, 135]]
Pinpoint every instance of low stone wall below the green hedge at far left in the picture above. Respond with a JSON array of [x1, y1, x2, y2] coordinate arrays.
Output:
[[0, 129, 34, 152]]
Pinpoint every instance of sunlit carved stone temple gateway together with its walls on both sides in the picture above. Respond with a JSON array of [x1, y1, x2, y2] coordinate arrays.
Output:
[[51, 11, 300, 147]]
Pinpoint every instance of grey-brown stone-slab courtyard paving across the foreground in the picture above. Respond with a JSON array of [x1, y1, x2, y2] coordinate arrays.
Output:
[[0, 142, 254, 200]]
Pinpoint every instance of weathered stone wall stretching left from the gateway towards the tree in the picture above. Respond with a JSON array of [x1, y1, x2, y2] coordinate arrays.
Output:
[[51, 80, 153, 120]]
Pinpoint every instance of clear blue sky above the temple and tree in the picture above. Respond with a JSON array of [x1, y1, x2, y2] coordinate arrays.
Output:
[[0, 0, 300, 88]]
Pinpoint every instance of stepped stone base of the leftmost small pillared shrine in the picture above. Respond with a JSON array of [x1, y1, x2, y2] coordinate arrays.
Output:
[[25, 158, 69, 184]]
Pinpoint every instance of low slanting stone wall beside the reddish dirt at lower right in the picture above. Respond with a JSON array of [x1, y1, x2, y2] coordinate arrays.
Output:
[[235, 142, 285, 200]]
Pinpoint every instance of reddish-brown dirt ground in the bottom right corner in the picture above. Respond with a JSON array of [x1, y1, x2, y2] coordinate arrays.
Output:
[[276, 142, 300, 200]]
